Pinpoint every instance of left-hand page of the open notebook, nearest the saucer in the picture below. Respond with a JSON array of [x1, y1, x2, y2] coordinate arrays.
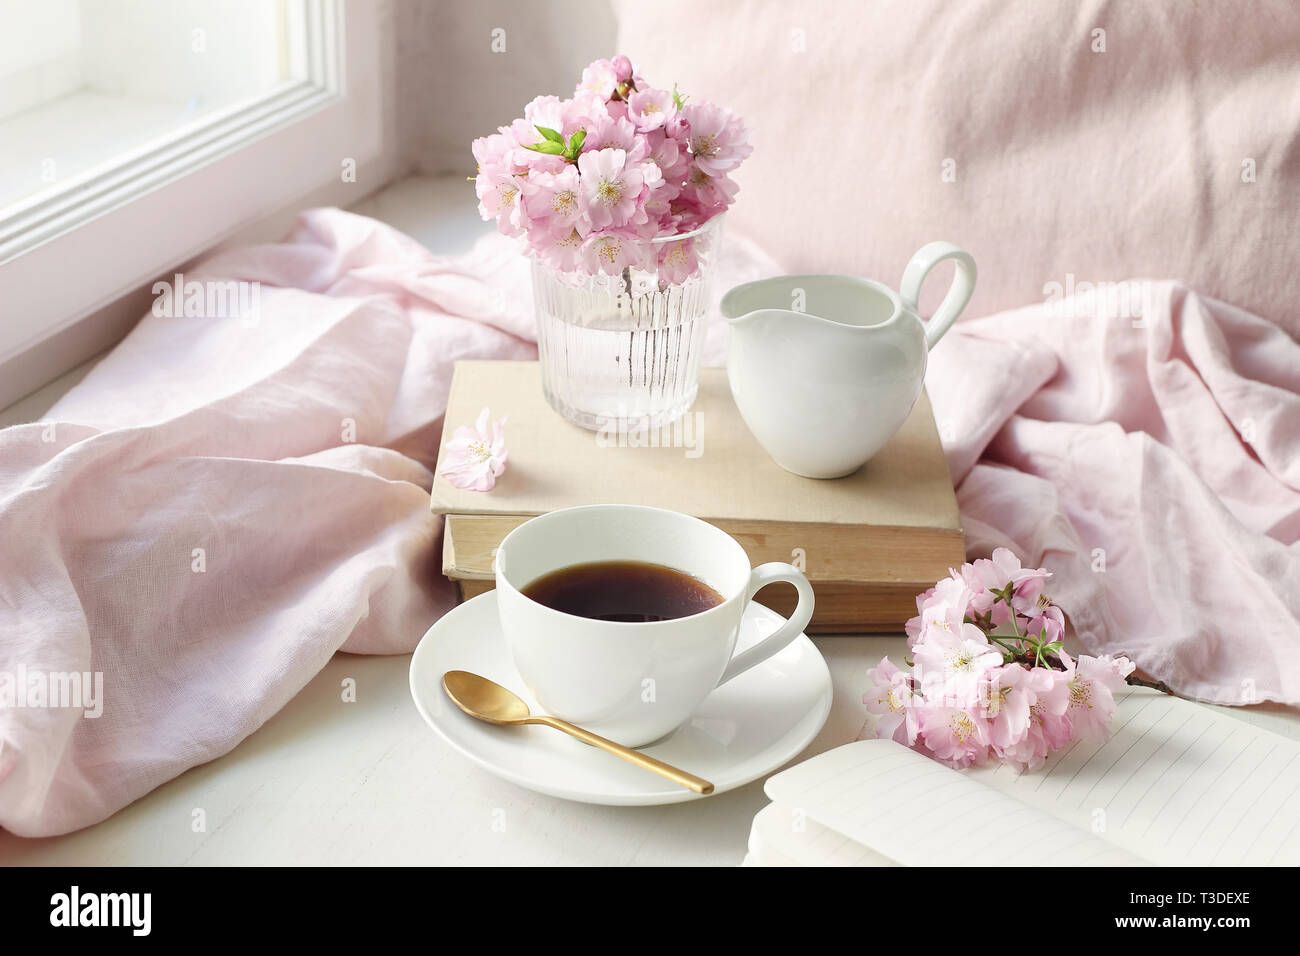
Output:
[[764, 740, 1141, 866]]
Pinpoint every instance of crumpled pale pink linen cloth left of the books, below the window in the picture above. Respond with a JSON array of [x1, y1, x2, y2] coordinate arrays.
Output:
[[0, 209, 776, 836]]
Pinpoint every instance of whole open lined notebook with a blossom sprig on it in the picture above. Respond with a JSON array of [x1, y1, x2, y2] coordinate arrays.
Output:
[[745, 689, 1300, 866]]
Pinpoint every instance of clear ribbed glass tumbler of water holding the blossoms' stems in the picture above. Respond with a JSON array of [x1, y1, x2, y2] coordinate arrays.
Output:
[[533, 216, 723, 433]]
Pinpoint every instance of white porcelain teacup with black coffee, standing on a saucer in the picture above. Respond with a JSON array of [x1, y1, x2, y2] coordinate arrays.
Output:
[[495, 505, 813, 747]]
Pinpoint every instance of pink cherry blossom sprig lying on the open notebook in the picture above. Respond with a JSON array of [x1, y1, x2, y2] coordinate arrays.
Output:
[[862, 548, 1138, 769]]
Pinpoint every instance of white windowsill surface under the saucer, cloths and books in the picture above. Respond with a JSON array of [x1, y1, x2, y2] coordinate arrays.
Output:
[[0, 179, 1300, 865]]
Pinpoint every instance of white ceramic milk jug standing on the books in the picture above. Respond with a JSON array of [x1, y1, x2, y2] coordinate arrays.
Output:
[[722, 242, 975, 479]]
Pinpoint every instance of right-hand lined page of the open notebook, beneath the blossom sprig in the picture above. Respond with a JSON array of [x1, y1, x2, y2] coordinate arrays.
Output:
[[967, 688, 1300, 866]]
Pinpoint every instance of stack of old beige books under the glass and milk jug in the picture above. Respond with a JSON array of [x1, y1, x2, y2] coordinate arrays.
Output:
[[432, 362, 963, 633]]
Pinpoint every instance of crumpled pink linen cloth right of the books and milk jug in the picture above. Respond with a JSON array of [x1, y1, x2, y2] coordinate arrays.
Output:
[[927, 281, 1300, 705]]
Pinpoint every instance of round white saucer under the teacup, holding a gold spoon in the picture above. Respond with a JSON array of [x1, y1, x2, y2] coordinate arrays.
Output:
[[411, 591, 831, 806]]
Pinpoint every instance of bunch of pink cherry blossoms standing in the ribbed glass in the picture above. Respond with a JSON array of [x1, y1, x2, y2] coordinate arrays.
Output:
[[473, 56, 753, 284]]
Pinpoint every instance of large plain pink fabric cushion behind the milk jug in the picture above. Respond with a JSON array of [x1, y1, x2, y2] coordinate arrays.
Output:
[[616, 0, 1300, 337]]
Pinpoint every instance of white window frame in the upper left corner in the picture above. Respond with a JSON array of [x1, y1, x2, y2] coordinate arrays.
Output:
[[0, 0, 389, 407]]
